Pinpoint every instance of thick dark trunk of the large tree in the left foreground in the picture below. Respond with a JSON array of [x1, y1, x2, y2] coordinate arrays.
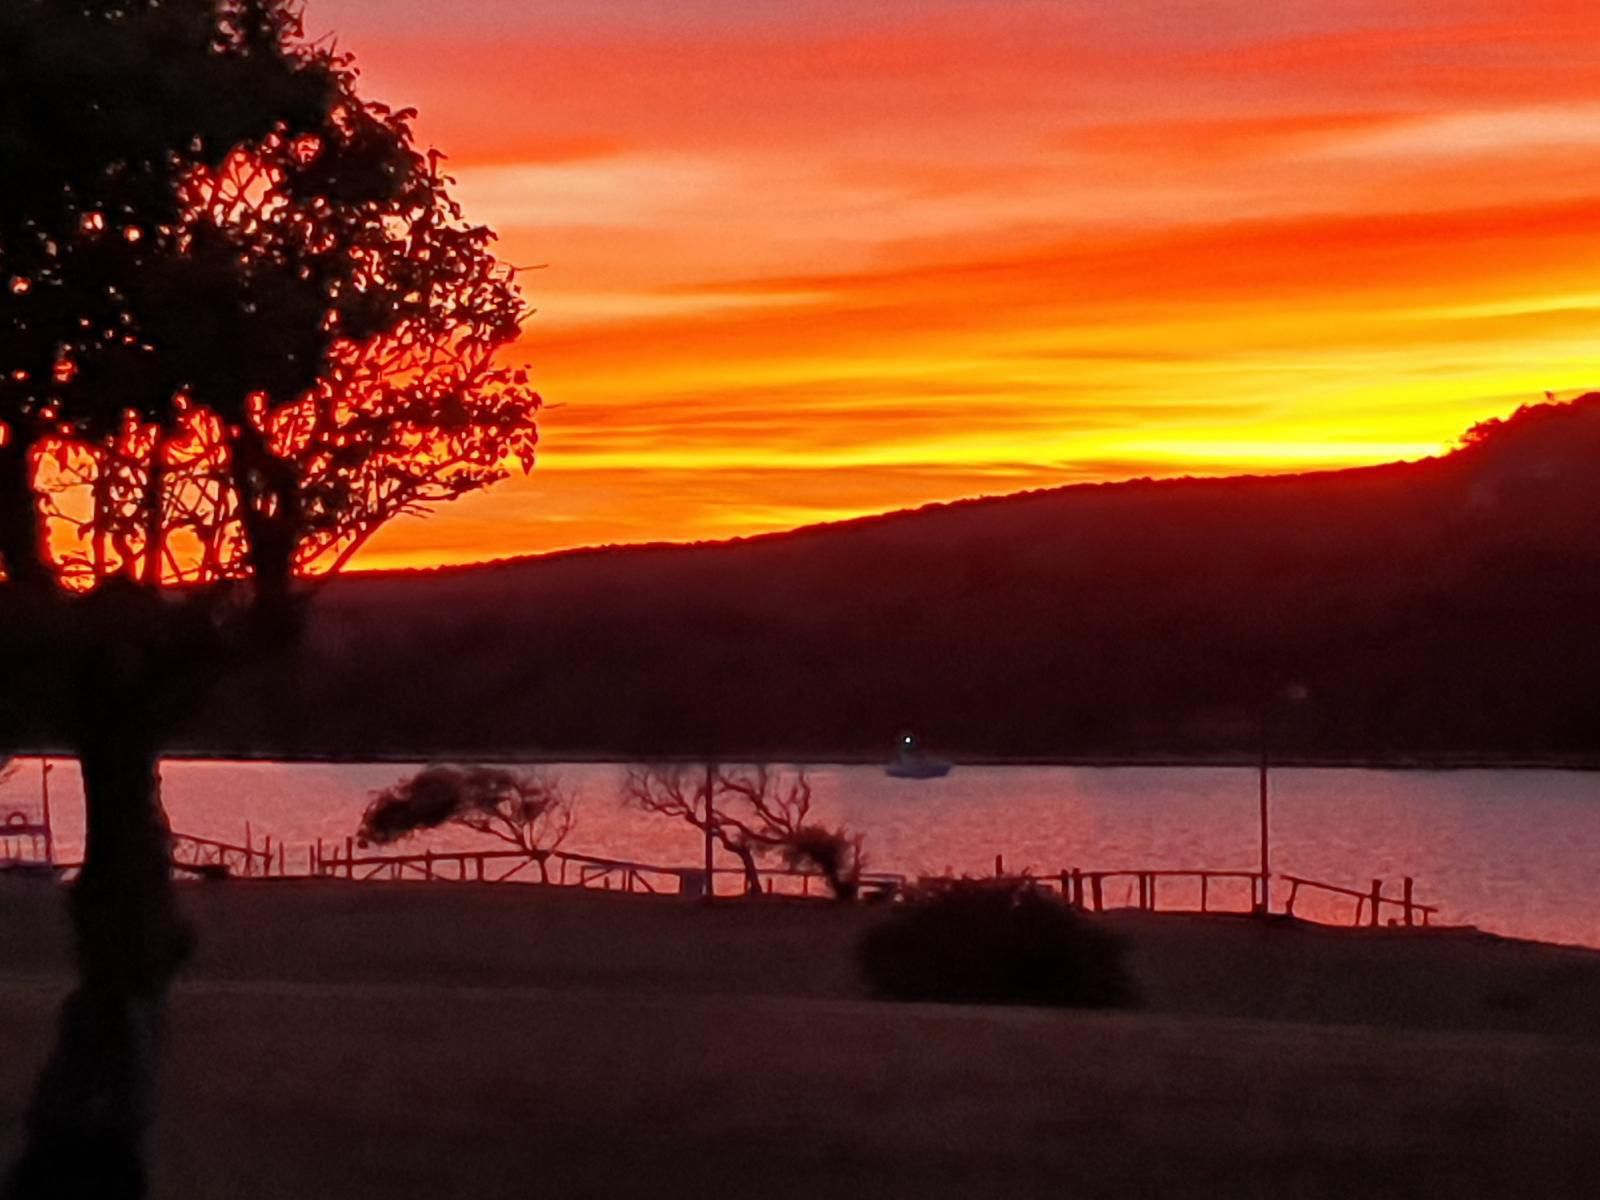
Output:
[[3, 729, 192, 1200]]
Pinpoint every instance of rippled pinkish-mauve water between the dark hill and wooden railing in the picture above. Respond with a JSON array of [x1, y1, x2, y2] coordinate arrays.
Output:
[[0, 762, 1600, 946]]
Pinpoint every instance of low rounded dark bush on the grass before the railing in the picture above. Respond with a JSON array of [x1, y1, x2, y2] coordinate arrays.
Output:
[[859, 880, 1136, 1008]]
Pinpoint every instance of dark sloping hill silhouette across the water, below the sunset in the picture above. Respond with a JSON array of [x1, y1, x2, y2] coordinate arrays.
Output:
[[190, 394, 1600, 760]]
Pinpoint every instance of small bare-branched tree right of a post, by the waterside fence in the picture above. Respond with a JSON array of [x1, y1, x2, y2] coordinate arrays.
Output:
[[622, 765, 861, 899]]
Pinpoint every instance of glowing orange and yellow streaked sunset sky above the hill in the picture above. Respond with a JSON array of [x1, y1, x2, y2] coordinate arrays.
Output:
[[307, 0, 1600, 566]]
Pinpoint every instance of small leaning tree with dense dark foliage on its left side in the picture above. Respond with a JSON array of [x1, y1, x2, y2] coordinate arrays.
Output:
[[358, 766, 578, 883]]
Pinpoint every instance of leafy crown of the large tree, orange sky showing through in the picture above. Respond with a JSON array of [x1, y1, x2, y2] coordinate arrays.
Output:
[[0, 0, 538, 601]]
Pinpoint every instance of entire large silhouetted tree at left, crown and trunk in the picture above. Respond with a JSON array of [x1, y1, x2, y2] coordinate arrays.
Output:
[[0, 0, 538, 1197]]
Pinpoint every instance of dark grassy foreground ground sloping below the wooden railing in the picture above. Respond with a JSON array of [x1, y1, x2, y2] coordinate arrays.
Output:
[[0, 883, 1600, 1200]]
